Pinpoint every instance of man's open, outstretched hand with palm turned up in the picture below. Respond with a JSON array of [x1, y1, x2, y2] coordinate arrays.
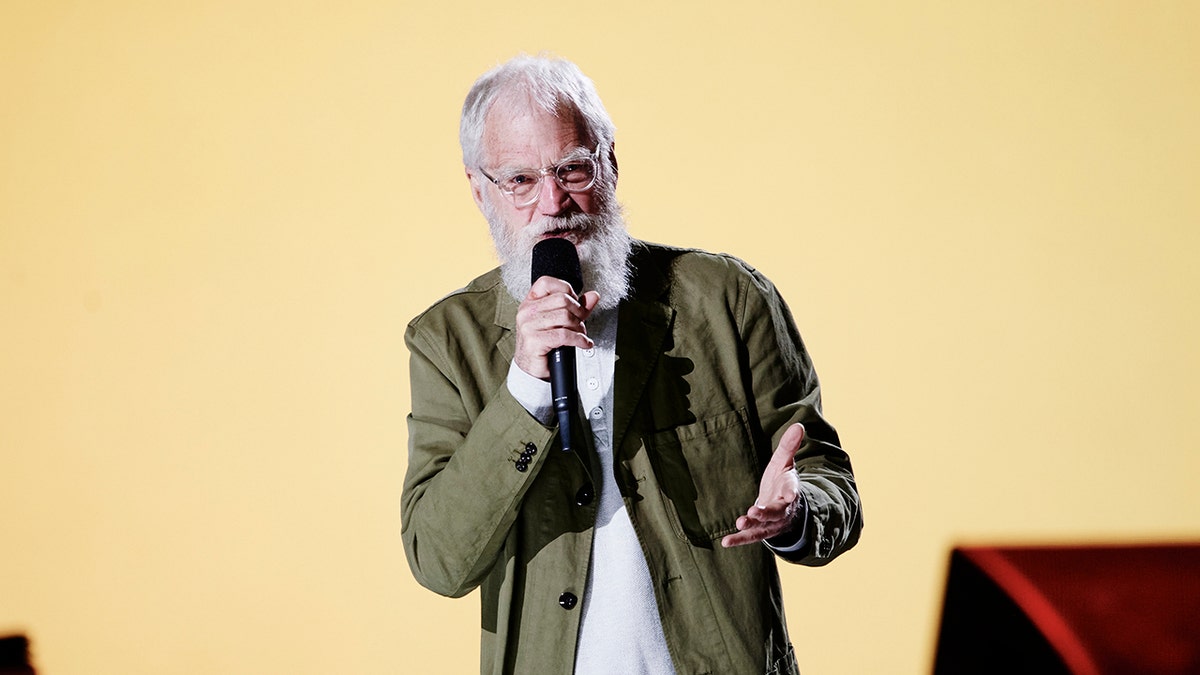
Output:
[[721, 423, 804, 548]]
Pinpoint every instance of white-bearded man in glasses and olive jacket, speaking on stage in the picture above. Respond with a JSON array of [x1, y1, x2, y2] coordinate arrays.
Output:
[[401, 56, 862, 675]]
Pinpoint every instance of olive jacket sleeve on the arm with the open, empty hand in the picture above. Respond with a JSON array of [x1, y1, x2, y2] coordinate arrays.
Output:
[[740, 263, 863, 566]]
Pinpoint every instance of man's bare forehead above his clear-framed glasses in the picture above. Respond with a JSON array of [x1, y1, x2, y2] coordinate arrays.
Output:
[[484, 97, 587, 167]]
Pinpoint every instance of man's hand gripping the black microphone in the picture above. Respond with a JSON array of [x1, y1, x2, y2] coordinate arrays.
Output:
[[512, 276, 600, 380]]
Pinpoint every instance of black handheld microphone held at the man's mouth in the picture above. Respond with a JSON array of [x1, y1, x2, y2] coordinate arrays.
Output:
[[529, 237, 583, 450]]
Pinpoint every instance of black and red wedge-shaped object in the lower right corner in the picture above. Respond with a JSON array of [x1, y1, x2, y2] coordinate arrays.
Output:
[[934, 544, 1200, 675]]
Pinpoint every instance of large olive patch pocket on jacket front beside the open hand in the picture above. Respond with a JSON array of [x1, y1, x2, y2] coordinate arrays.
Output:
[[648, 408, 761, 546]]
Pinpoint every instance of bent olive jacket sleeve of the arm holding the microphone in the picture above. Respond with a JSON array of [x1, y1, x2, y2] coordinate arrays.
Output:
[[401, 314, 553, 597]]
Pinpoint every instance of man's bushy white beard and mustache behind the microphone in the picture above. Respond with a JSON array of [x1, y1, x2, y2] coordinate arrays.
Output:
[[482, 187, 634, 310]]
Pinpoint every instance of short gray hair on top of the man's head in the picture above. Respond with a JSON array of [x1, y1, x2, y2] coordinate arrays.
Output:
[[458, 54, 616, 173]]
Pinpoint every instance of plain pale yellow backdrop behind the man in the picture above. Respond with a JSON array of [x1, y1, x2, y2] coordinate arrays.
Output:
[[0, 0, 1200, 675]]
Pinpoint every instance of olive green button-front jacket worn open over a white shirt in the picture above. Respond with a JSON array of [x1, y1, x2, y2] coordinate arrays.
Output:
[[401, 243, 862, 675]]
